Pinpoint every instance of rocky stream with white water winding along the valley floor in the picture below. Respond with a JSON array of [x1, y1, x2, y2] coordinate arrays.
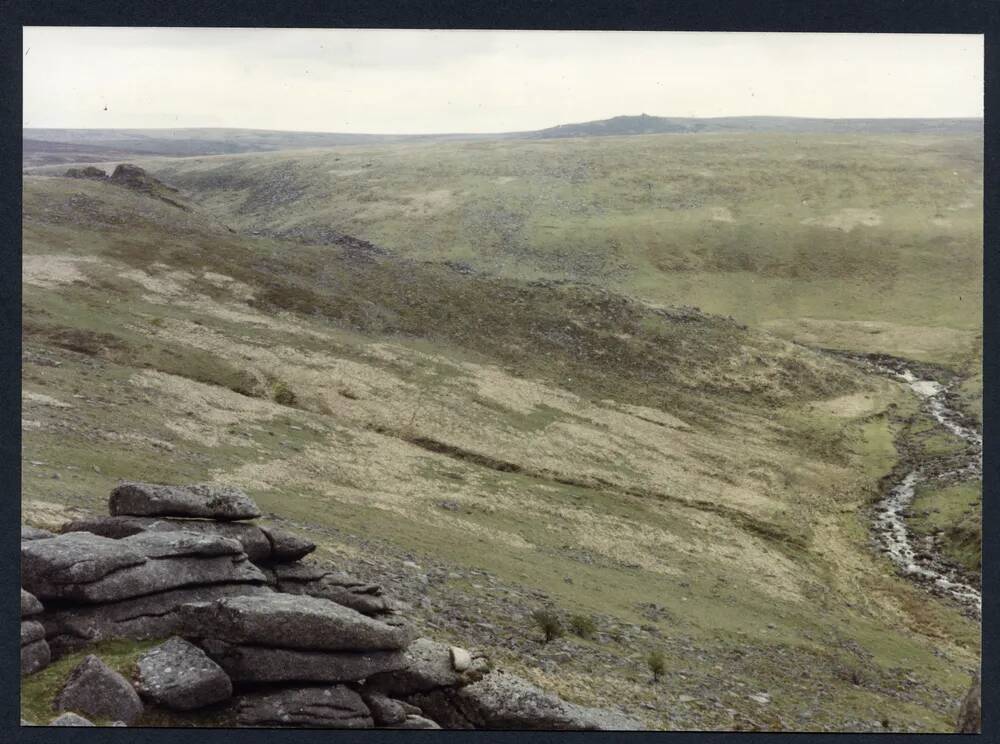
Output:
[[875, 365, 983, 616]]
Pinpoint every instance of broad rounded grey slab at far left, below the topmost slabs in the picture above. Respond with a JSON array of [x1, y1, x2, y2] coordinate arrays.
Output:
[[21, 531, 265, 603]]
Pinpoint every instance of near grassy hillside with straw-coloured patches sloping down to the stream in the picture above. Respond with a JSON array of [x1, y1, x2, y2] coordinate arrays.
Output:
[[22, 178, 979, 730]]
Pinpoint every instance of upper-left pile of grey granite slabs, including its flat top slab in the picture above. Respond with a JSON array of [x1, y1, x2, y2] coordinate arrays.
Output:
[[21, 483, 284, 657]]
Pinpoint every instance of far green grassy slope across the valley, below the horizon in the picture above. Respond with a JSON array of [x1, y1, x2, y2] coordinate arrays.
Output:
[[58, 134, 982, 364]]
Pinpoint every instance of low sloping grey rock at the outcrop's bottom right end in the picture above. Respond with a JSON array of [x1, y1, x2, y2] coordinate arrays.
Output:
[[411, 672, 642, 731]]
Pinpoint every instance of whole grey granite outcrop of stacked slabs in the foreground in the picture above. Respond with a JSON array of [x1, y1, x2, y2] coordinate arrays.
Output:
[[21, 483, 639, 729]]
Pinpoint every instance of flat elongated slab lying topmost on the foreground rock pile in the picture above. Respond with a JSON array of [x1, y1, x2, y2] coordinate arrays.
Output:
[[108, 482, 261, 522]]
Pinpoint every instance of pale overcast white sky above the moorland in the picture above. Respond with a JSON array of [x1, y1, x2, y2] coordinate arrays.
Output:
[[23, 27, 983, 134]]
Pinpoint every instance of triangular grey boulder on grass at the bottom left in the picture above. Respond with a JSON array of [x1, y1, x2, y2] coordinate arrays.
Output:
[[54, 654, 142, 724]]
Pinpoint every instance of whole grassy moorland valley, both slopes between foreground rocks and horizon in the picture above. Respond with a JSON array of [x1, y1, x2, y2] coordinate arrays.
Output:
[[21, 131, 983, 732]]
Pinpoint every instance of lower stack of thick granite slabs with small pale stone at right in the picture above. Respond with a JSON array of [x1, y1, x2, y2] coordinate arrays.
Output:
[[181, 592, 485, 728]]
